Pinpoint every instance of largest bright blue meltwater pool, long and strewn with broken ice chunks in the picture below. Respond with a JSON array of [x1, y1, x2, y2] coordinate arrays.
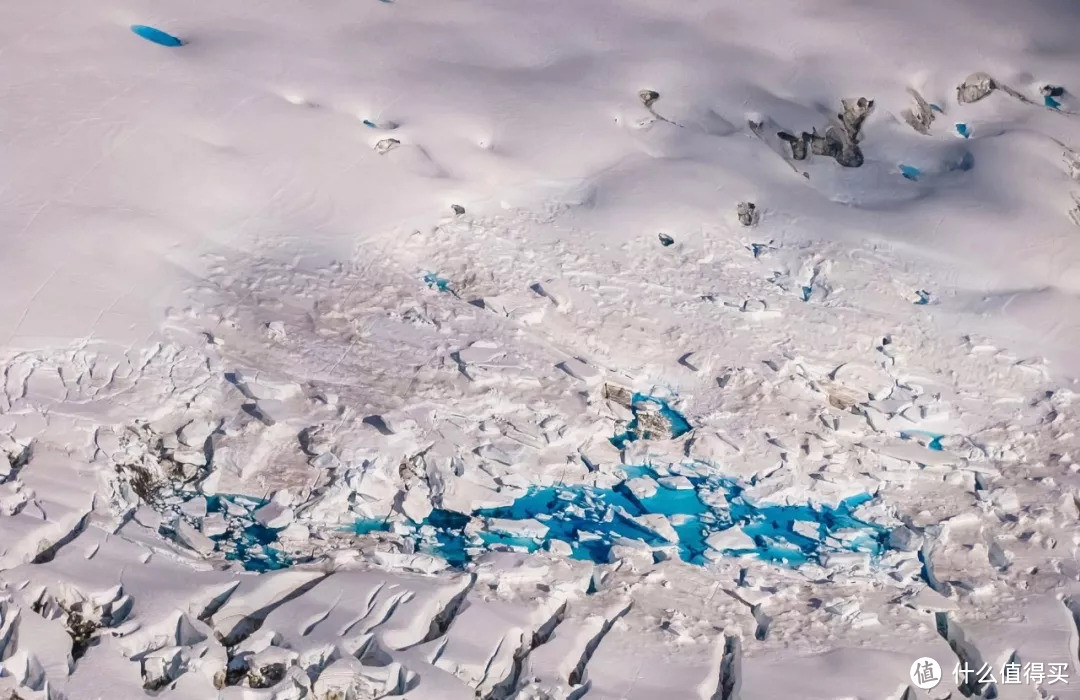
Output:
[[357, 467, 887, 567]]
